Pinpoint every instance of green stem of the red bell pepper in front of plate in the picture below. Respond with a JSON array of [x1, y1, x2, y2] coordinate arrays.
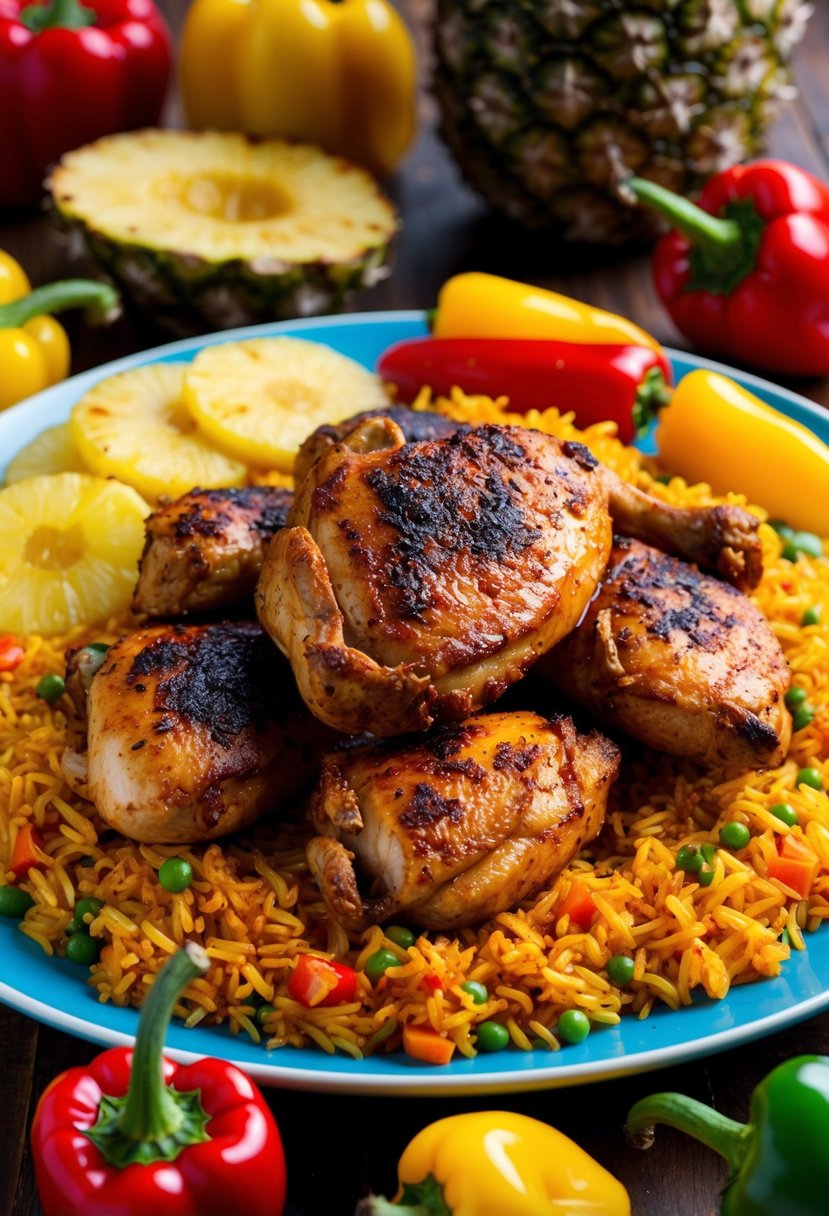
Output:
[[86, 941, 210, 1169]]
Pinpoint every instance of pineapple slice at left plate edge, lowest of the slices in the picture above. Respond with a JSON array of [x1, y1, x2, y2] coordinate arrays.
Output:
[[0, 473, 150, 635]]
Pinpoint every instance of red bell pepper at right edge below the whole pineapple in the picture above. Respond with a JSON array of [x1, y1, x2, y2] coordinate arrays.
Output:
[[627, 161, 829, 376]]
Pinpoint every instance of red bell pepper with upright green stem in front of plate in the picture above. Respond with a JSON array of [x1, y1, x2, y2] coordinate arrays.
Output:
[[32, 942, 286, 1216]]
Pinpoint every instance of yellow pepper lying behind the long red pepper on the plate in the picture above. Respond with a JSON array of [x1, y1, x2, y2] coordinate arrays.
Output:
[[432, 271, 661, 351]]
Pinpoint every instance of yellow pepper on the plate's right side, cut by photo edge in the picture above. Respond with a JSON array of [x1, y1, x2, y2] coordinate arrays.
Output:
[[655, 368, 829, 537]]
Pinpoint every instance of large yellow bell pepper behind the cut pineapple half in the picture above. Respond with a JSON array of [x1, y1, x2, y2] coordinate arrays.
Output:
[[179, 0, 417, 178]]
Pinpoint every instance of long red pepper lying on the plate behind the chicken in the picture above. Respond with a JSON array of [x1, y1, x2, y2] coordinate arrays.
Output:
[[377, 338, 671, 443]]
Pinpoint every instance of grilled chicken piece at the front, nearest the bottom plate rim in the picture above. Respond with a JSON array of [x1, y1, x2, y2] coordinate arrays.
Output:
[[306, 711, 619, 933]]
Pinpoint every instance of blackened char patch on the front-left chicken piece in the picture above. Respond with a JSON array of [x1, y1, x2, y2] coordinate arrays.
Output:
[[126, 621, 286, 748]]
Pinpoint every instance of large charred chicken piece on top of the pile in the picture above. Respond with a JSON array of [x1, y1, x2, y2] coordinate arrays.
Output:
[[255, 418, 757, 736]]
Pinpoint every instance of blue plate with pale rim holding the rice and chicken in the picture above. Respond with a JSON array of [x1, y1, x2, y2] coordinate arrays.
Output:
[[0, 313, 829, 1094]]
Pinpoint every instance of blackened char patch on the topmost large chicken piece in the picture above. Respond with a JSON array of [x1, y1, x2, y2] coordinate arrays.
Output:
[[366, 427, 541, 618]]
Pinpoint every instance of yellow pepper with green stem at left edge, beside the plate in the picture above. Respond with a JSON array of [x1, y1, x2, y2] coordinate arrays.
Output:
[[0, 249, 118, 410]]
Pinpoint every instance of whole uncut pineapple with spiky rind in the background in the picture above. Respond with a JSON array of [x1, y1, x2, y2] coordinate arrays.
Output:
[[434, 0, 812, 242]]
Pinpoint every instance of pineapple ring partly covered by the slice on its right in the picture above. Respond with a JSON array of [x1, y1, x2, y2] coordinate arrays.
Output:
[[72, 364, 247, 501]]
